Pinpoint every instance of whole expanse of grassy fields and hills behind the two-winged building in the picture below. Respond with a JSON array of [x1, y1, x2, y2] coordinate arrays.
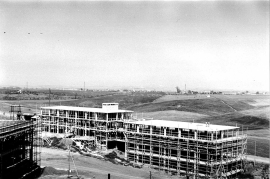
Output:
[[0, 93, 270, 157]]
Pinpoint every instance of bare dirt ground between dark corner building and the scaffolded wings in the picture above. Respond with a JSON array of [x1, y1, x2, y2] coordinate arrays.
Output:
[[40, 148, 179, 179]]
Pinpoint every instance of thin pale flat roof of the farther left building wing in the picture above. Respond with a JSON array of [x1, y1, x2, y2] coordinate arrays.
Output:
[[41, 106, 133, 113]]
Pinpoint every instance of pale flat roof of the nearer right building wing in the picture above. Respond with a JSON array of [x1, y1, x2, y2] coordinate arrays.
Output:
[[126, 120, 239, 131]]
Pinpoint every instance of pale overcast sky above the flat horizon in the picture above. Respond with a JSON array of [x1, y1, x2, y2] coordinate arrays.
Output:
[[0, 1, 269, 91]]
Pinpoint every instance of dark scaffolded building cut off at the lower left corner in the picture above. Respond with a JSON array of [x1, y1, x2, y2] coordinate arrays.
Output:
[[0, 120, 40, 179]]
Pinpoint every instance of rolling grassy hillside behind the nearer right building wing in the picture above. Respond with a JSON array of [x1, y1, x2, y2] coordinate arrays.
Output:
[[133, 95, 270, 158]]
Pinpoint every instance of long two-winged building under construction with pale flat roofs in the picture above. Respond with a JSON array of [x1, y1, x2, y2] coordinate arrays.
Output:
[[41, 103, 247, 178]]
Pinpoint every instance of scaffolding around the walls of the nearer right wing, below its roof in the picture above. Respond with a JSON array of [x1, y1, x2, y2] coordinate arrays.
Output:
[[125, 120, 247, 178]]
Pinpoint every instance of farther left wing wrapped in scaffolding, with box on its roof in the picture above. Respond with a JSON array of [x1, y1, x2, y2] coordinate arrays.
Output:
[[41, 103, 132, 149]]
